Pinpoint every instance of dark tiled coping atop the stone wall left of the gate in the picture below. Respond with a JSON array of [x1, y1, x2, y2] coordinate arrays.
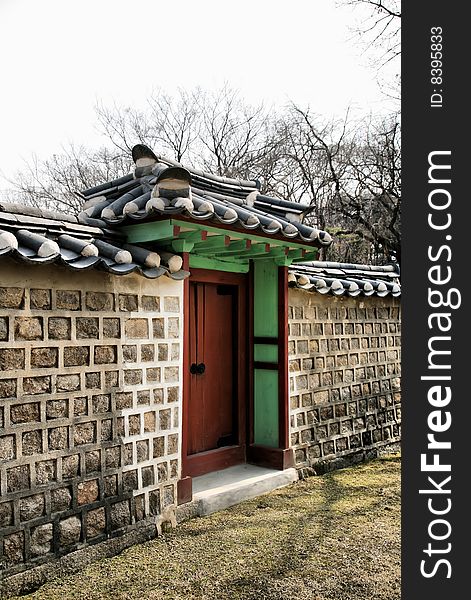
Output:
[[0, 203, 189, 279]]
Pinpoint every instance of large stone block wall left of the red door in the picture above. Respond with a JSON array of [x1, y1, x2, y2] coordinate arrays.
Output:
[[0, 260, 183, 576]]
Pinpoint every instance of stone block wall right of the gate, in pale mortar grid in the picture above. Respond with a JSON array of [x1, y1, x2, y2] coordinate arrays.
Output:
[[288, 288, 401, 474]]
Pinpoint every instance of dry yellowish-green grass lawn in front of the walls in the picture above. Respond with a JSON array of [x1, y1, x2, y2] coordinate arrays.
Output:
[[10, 456, 400, 600]]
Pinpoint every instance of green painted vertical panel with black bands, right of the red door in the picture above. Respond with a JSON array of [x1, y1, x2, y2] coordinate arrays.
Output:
[[254, 259, 279, 448]]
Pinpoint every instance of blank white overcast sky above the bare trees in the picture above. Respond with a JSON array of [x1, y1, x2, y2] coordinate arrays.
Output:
[[0, 0, 398, 188]]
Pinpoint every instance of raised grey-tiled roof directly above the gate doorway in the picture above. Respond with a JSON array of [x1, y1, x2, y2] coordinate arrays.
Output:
[[78, 144, 332, 247]]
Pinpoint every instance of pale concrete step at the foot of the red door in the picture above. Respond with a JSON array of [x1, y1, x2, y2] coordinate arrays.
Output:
[[193, 464, 298, 516]]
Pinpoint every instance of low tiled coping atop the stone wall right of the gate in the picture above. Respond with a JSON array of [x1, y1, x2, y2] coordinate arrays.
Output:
[[288, 261, 401, 298]]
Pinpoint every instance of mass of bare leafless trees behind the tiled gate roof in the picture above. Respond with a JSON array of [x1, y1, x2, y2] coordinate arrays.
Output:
[[5, 86, 401, 262]]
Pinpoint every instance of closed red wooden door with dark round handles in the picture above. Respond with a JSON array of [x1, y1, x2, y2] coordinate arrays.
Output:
[[185, 275, 246, 476]]
